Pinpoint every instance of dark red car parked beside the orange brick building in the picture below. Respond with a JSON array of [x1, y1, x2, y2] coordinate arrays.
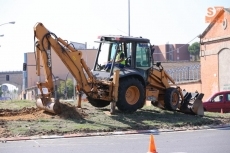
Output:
[[203, 91, 230, 113]]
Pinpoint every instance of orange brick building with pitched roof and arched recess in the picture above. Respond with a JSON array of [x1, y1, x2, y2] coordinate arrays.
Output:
[[200, 8, 230, 99]]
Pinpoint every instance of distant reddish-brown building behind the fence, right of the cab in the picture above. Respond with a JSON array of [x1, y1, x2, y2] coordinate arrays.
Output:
[[153, 44, 190, 61]]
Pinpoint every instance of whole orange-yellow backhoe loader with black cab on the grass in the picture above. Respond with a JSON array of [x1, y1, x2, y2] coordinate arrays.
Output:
[[31, 23, 204, 115]]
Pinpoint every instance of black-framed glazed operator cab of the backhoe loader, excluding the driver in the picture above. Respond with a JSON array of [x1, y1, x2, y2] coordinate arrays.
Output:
[[93, 35, 152, 76]]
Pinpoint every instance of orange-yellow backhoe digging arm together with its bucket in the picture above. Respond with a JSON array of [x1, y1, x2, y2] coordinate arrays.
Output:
[[34, 23, 101, 113]]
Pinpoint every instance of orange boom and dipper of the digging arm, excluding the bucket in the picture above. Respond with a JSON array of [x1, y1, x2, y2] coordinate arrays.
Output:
[[34, 23, 93, 93]]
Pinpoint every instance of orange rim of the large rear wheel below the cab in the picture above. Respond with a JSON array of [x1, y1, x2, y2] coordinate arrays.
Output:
[[125, 86, 140, 105]]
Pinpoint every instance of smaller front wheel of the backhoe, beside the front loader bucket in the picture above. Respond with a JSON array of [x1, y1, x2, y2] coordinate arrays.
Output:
[[164, 87, 180, 111]]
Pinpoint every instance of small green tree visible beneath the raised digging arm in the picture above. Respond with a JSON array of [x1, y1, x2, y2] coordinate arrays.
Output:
[[58, 79, 74, 98]]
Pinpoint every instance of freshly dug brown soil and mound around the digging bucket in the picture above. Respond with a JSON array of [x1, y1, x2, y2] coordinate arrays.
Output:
[[0, 103, 88, 137]]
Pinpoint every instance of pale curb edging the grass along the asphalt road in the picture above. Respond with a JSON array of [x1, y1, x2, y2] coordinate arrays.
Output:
[[0, 124, 230, 143]]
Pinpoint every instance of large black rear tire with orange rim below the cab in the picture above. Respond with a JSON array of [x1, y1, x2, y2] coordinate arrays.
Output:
[[116, 78, 145, 112]]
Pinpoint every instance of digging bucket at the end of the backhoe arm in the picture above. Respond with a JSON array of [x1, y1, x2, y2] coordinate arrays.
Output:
[[36, 98, 61, 114]]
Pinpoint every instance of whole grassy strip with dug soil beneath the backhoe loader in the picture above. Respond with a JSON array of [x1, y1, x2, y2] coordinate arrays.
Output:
[[0, 102, 230, 138]]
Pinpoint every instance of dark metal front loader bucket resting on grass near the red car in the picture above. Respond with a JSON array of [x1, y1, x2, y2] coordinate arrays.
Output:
[[179, 92, 204, 116]]
